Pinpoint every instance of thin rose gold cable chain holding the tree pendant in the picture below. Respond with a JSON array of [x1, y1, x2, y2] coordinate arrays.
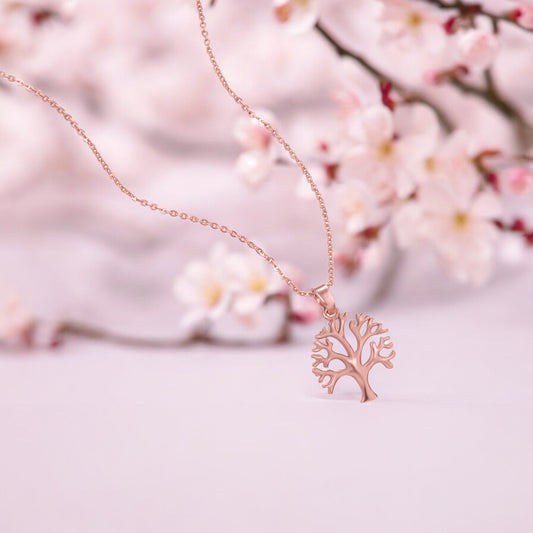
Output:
[[0, 0, 334, 296]]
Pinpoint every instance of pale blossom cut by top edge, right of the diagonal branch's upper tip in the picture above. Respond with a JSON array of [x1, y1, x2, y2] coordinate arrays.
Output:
[[381, 0, 446, 53]]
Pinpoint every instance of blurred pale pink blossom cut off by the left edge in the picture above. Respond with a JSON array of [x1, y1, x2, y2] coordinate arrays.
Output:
[[0, 288, 34, 343]]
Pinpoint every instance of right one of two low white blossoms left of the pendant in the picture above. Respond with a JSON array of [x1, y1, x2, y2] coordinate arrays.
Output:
[[226, 252, 281, 319]]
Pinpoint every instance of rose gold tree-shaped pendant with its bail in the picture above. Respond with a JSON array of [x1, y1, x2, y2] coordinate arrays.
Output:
[[311, 285, 396, 403]]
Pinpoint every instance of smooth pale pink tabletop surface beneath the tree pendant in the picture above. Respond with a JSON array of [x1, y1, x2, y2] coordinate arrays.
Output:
[[0, 266, 533, 533]]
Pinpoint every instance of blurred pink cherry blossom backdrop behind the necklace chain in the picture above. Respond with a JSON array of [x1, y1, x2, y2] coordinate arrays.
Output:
[[0, 0, 533, 348]]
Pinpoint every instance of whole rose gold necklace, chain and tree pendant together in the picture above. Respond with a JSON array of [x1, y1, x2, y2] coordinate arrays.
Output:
[[0, 0, 395, 402]]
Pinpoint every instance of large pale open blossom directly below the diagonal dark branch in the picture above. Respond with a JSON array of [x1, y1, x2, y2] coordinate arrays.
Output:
[[340, 105, 438, 200]]
